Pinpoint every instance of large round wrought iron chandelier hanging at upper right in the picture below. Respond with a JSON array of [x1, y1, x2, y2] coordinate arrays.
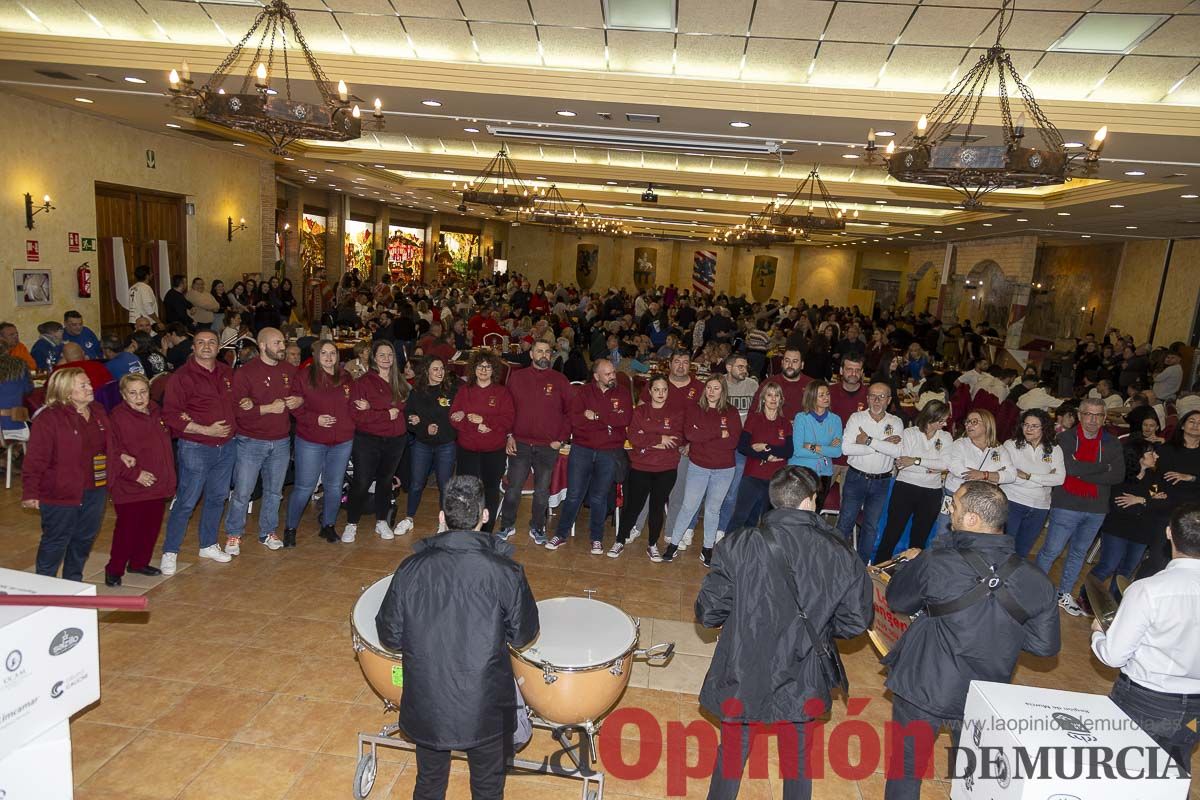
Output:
[[866, 0, 1108, 209]]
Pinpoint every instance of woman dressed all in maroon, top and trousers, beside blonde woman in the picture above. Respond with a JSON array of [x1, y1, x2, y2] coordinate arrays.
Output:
[[104, 372, 175, 587]]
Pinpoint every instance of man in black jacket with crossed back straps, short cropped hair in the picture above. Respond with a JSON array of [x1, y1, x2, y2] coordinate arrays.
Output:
[[883, 481, 1060, 800]]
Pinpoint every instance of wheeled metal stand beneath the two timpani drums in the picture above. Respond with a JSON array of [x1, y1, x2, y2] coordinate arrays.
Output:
[[354, 709, 604, 800]]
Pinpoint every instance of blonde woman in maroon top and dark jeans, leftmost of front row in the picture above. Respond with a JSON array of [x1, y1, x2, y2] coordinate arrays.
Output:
[[20, 367, 109, 581]]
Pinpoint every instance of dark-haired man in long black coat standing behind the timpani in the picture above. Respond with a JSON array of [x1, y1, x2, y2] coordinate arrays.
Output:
[[376, 475, 539, 800]]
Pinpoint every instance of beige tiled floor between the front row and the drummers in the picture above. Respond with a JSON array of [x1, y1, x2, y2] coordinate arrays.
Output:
[[0, 472, 1200, 800]]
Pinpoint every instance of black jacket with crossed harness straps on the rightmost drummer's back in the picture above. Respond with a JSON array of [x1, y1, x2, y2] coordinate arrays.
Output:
[[883, 531, 1060, 720]]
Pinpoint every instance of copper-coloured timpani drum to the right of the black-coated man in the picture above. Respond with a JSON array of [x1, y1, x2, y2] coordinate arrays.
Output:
[[509, 597, 674, 726]]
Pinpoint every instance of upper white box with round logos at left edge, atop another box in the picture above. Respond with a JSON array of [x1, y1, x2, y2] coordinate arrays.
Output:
[[0, 570, 100, 759]]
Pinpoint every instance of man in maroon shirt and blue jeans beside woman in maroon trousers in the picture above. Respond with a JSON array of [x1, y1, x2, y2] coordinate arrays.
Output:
[[161, 331, 238, 575]]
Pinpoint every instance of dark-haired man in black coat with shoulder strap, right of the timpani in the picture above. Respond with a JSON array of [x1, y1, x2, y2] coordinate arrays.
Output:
[[696, 467, 875, 800]]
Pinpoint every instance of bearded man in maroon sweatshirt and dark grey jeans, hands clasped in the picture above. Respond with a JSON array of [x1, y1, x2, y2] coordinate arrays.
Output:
[[500, 341, 571, 545]]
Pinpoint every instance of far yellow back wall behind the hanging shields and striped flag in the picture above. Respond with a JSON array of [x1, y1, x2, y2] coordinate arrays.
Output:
[[508, 224, 856, 303]]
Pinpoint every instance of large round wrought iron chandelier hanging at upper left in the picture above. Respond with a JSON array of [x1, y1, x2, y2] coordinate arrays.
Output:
[[168, 0, 383, 155]]
